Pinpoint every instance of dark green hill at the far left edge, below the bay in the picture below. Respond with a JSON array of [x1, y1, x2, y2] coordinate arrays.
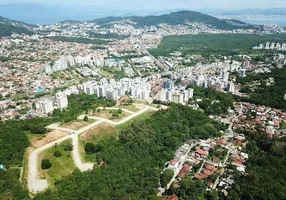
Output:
[[0, 17, 33, 37]]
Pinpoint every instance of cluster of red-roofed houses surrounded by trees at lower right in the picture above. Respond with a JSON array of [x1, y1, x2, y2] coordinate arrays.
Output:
[[158, 134, 249, 196]]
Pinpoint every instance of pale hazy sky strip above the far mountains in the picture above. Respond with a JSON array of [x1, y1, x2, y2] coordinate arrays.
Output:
[[0, 0, 286, 11]]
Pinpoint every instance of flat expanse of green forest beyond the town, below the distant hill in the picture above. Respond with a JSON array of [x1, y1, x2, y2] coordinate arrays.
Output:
[[150, 34, 286, 56]]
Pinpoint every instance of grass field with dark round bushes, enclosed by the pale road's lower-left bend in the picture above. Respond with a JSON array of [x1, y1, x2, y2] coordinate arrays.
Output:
[[39, 139, 75, 188]]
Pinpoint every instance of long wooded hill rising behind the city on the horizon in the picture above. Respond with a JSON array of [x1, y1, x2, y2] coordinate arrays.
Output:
[[92, 11, 254, 30]]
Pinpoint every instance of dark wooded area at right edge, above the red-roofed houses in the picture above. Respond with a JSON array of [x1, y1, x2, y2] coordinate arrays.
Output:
[[237, 66, 286, 111]]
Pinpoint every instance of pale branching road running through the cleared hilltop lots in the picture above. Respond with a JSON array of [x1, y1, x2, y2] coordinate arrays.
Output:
[[28, 104, 154, 193]]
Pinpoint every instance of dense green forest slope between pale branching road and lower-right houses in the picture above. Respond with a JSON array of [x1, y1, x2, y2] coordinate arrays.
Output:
[[35, 105, 224, 200]]
